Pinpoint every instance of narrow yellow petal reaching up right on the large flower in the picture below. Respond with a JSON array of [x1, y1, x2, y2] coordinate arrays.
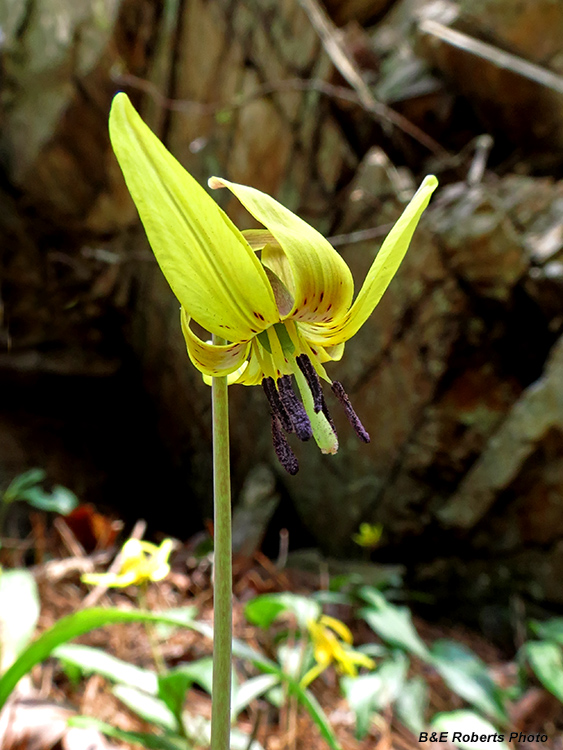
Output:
[[306, 175, 438, 347]]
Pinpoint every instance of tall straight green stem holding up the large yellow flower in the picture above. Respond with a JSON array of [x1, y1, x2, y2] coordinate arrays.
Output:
[[211, 335, 233, 750]]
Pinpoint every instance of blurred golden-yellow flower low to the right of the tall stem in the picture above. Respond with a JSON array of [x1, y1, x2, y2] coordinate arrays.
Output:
[[301, 615, 375, 687]]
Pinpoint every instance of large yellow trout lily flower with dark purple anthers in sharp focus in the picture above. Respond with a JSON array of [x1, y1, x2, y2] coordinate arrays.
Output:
[[109, 93, 438, 474]]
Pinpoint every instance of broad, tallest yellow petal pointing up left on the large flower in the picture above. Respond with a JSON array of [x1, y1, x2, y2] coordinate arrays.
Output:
[[109, 93, 279, 341]]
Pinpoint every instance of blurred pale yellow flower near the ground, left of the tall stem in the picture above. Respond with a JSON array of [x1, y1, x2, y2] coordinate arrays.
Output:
[[82, 539, 174, 588]]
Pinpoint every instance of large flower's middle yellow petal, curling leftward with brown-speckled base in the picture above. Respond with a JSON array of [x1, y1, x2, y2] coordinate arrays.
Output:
[[209, 177, 354, 328]]
